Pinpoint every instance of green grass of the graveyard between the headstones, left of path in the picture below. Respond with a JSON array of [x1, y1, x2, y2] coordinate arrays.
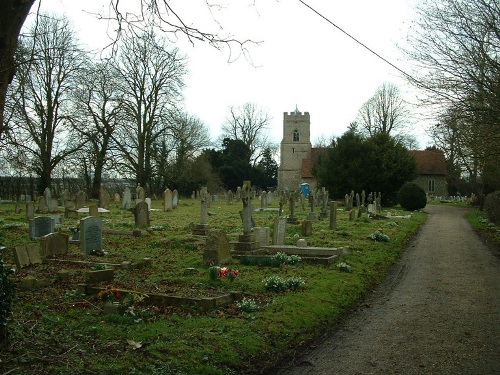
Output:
[[0, 199, 426, 374]]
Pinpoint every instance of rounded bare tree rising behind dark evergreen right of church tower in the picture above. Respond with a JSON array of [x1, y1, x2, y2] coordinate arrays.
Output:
[[356, 83, 409, 137]]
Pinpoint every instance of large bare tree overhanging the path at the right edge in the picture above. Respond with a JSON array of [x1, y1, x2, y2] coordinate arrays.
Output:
[[408, 0, 500, 192]]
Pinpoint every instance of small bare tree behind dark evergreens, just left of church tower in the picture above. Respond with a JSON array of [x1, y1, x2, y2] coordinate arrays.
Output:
[[220, 103, 276, 166]]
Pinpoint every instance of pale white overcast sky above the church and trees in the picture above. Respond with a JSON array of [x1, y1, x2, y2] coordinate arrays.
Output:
[[32, 0, 429, 148]]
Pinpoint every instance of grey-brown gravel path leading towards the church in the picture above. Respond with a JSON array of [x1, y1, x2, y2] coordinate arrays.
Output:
[[276, 205, 500, 375]]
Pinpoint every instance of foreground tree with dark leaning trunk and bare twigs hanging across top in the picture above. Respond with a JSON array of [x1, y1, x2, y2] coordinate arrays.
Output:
[[0, 0, 258, 140]]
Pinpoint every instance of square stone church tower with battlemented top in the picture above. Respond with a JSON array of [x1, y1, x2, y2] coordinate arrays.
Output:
[[278, 107, 311, 191]]
